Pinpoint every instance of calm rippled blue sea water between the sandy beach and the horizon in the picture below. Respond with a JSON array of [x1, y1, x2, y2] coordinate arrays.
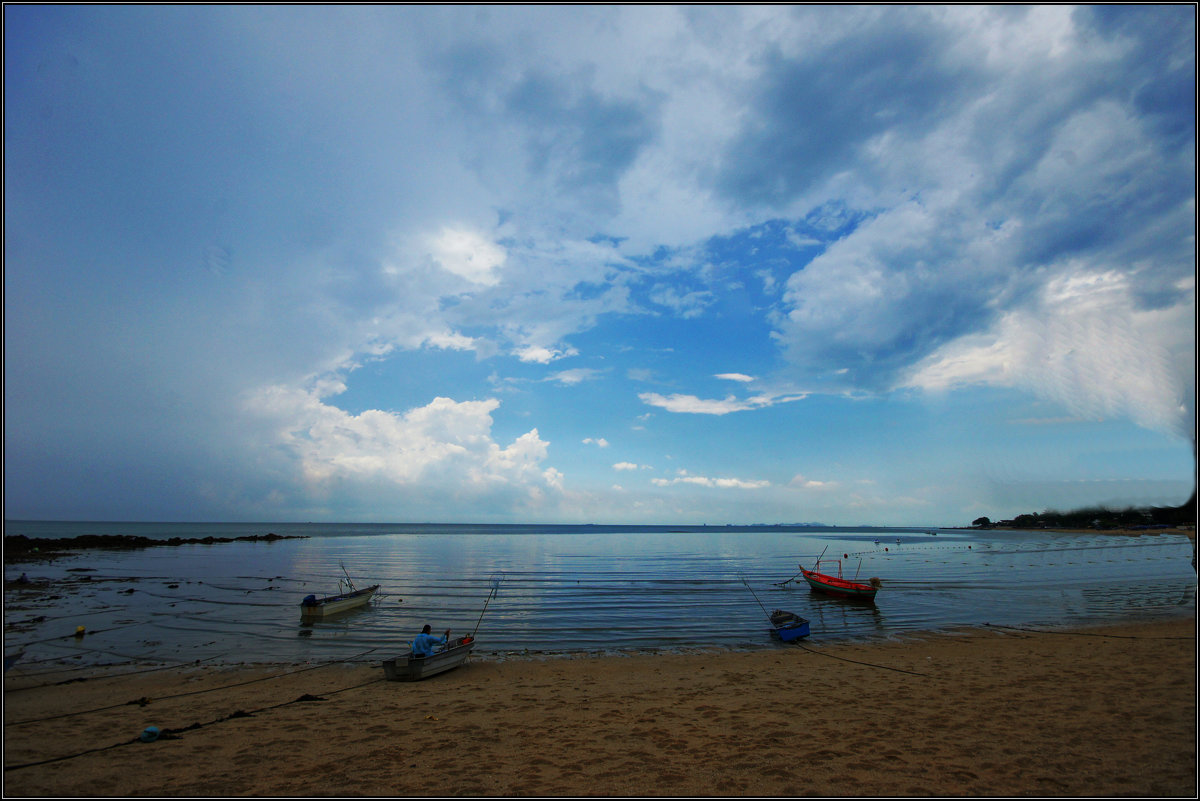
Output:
[[5, 520, 1196, 664]]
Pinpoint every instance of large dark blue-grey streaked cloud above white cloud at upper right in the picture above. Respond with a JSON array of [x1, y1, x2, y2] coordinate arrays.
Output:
[[716, 8, 1195, 407]]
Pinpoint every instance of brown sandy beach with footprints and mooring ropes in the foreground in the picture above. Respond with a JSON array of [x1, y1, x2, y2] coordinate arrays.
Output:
[[4, 618, 1196, 797]]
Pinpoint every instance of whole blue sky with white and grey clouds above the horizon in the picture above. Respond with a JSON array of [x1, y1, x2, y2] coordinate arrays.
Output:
[[4, 5, 1196, 526]]
